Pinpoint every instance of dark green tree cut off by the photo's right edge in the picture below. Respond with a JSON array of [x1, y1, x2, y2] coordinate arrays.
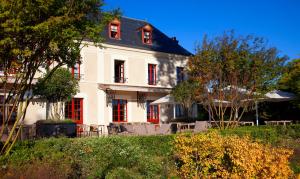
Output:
[[278, 59, 300, 108]]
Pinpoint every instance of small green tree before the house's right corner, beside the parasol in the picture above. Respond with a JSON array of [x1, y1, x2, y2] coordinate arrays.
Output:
[[171, 80, 198, 118]]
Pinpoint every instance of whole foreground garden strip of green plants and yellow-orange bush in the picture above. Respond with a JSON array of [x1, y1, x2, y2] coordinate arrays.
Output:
[[0, 125, 300, 178]]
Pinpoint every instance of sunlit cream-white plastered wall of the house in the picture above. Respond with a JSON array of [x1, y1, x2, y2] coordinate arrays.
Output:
[[25, 44, 187, 125]]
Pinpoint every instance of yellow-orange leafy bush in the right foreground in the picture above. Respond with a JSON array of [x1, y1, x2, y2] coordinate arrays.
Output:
[[174, 132, 293, 178]]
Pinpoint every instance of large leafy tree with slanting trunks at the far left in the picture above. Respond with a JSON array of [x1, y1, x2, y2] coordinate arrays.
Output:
[[0, 0, 117, 155]]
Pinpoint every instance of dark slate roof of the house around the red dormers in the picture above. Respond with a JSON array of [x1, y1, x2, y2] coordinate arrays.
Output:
[[102, 17, 192, 56]]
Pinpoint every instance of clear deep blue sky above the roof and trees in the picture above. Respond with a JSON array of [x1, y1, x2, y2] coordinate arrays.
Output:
[[104, 0, 300, 58]]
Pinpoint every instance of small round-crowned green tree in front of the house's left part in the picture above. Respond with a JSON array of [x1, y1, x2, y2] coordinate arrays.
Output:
[[33, 68, 78, 120]]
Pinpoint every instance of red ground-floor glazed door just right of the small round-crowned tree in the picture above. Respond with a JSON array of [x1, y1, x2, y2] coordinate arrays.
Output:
[[65, 98, 83, 124]]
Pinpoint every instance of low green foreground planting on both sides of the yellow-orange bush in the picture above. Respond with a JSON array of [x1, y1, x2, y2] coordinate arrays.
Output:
[[0, 125, 300, 178]]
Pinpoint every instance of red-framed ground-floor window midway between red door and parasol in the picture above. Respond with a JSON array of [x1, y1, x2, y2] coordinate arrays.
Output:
[[112, 99, 127, 122]]
